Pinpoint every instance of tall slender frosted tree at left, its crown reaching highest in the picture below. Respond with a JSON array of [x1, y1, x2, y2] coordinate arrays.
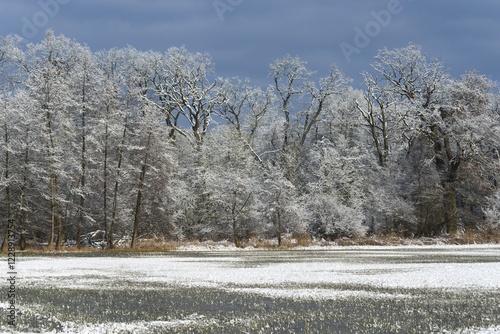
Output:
[[23, 30, 88, 248]]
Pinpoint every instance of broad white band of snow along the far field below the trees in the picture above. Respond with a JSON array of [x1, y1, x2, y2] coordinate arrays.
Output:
[[17, 246, 500, 289]]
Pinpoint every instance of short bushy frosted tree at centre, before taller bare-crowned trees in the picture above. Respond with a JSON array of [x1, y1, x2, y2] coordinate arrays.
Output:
[[203, 127, 265, 246]]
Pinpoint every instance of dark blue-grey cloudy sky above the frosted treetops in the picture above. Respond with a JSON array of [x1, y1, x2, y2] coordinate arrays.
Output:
[[0, 0, 500, 85]]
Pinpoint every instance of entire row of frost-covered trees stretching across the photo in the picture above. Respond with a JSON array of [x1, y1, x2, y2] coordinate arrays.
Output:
[[0, 30, 500, 248]]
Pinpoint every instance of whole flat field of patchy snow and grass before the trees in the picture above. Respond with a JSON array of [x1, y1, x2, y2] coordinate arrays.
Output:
[[0, 245, 500, 333]]
